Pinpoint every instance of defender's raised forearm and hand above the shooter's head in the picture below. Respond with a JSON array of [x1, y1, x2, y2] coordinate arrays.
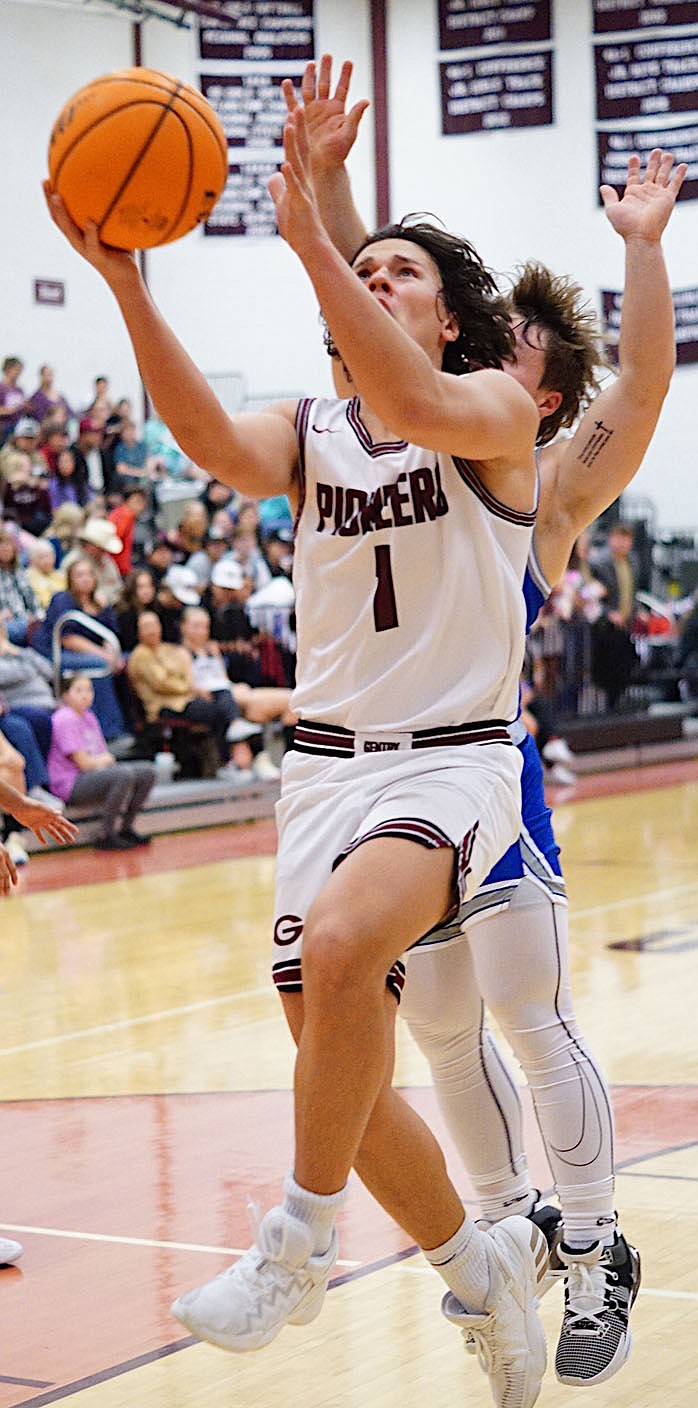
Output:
[[281, 54, 369, 262]]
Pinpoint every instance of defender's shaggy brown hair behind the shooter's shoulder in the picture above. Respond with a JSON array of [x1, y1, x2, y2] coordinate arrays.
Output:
[[508, 260, 608, 445]]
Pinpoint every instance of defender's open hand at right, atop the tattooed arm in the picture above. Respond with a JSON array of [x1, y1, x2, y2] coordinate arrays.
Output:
[[601, 146, 688, 241]]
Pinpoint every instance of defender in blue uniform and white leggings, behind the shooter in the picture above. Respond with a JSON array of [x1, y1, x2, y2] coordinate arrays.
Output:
[[284, 56, 685, 1384]]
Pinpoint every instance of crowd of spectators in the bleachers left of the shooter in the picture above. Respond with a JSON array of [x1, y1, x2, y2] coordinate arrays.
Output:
[[0, 356, 294, 860]]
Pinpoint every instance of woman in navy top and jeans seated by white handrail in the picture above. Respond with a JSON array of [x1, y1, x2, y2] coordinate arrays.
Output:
[[32, 558, 125, 739]]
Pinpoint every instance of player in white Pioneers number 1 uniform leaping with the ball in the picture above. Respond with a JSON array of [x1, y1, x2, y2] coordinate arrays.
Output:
[[46, 113, 547, 1408]]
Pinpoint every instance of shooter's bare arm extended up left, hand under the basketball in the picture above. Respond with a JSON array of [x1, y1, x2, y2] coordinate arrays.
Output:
[[44, 182, 297, 497]]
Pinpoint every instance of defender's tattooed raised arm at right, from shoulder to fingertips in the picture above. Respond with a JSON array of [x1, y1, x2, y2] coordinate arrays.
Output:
[[536, 148, 687, 582]]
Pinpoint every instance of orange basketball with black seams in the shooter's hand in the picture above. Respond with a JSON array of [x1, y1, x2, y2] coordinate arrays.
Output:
[[48, 68, 228, 249]]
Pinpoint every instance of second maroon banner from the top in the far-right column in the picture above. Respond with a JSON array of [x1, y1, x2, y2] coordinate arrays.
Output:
[[594, 34, 698, 121]]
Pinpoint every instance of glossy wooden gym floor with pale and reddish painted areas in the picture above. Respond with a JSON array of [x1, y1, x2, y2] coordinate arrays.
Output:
[[0, 762, 698, 1408]]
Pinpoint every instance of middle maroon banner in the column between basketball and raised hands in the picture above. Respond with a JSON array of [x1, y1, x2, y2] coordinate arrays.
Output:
[[201, 68, 303, 151]]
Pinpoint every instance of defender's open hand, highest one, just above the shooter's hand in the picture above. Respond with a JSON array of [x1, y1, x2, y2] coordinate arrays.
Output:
[[281, 54, 369, 170]]
